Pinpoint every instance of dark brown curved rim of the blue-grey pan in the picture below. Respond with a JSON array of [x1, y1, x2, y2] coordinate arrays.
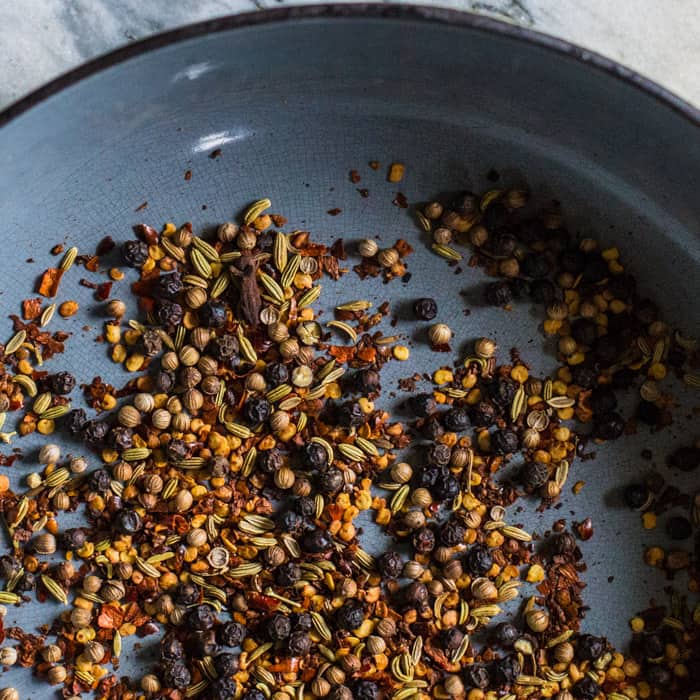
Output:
[[0, 3, 700, 128]]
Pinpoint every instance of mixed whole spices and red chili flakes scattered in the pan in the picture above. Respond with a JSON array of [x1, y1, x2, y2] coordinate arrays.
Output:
[[0, 175, 700, 700]]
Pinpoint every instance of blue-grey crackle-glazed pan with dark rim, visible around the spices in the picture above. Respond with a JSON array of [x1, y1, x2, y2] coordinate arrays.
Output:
[[0, 5, 700, 698]]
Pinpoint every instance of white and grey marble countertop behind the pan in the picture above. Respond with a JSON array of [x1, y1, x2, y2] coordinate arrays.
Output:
[[0, 0, 700, 109]]
